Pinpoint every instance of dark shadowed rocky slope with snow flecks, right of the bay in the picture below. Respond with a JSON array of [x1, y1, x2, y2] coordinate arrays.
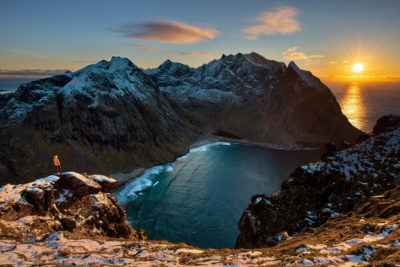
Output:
[[236, 117, 400, 248]]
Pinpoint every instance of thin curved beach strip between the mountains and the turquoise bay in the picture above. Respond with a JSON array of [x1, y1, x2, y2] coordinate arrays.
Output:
[[114, 134, 321, 193]]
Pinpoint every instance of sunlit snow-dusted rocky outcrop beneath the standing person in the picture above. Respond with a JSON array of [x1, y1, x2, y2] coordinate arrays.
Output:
[[0, 172, 145, 240]]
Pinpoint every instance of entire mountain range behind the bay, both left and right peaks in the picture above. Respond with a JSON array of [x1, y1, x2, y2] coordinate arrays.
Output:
[[0, 53, 360, 184]]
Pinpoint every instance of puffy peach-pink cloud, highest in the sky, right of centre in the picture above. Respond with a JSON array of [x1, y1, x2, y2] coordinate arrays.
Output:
[[242, 6, 301, 40]]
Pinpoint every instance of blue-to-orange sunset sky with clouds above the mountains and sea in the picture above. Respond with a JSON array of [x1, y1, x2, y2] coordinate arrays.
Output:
[[0, 0, 400, 80]]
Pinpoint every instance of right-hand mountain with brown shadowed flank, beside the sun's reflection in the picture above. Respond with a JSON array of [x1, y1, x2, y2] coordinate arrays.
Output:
[[147, 53, 361, 147]]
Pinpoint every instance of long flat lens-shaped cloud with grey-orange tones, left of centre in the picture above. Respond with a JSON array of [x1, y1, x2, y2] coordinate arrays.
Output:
[[117, 20, 220, 44]]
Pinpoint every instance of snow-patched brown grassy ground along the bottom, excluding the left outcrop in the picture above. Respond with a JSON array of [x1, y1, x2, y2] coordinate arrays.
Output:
[[0, 178, 400, 266]]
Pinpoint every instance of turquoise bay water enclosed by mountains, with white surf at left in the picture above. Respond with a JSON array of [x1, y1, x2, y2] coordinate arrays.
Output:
[[117, 143, 320, 248]]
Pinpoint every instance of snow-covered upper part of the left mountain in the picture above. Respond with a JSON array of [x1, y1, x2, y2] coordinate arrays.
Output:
[[3, 57, 161, 123]]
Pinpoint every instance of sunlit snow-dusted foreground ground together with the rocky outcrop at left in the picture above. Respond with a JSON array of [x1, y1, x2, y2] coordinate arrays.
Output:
[[0, 172, 400, 266]]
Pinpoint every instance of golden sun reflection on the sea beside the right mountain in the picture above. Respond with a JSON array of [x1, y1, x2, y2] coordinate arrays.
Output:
[[341, 83, 366, 130]]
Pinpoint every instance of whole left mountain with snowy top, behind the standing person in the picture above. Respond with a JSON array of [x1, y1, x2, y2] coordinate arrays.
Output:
[[0, 57, 196, 186]]
